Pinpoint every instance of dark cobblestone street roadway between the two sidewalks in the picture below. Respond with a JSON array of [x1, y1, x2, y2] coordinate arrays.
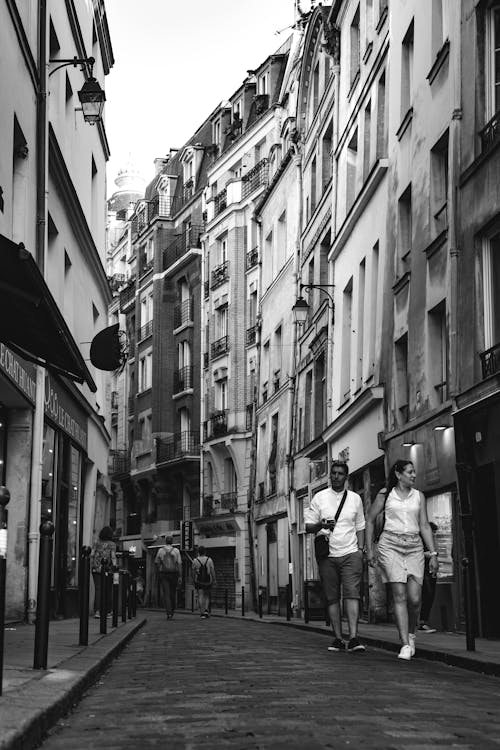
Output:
[[42, 613, 500, 750]]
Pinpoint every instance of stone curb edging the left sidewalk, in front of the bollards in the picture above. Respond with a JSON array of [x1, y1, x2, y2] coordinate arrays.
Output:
[[0, 617, 147, 750]]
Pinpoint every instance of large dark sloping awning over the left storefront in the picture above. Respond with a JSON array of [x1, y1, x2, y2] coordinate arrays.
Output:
[[0, 234, 97, 393]]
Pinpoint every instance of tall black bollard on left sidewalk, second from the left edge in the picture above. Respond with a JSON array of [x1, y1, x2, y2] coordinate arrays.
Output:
[[33, 521, 54, 669]]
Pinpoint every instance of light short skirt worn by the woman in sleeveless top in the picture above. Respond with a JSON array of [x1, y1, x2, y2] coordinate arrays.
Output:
[[377, 531, 425, 584]]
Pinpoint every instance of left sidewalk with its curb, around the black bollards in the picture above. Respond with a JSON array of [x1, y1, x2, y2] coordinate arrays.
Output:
[[0, 610, 146, 750]]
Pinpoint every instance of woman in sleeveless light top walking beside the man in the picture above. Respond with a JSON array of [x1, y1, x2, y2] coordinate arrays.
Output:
[[365, 460, 439, 659]]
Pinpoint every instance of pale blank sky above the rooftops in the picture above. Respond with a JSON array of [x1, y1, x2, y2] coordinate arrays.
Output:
[[105, 0, 304, 194]]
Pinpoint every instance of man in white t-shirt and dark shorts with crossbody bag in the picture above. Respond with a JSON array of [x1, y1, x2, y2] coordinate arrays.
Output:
[[304, 461, 365, 652]]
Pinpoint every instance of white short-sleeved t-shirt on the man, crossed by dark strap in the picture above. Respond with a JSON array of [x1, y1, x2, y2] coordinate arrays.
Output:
[[304, 487, 365, 557]]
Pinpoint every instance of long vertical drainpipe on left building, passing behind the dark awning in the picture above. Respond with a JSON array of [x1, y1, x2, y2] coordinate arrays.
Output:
[[27, 0, 48, 623]]
